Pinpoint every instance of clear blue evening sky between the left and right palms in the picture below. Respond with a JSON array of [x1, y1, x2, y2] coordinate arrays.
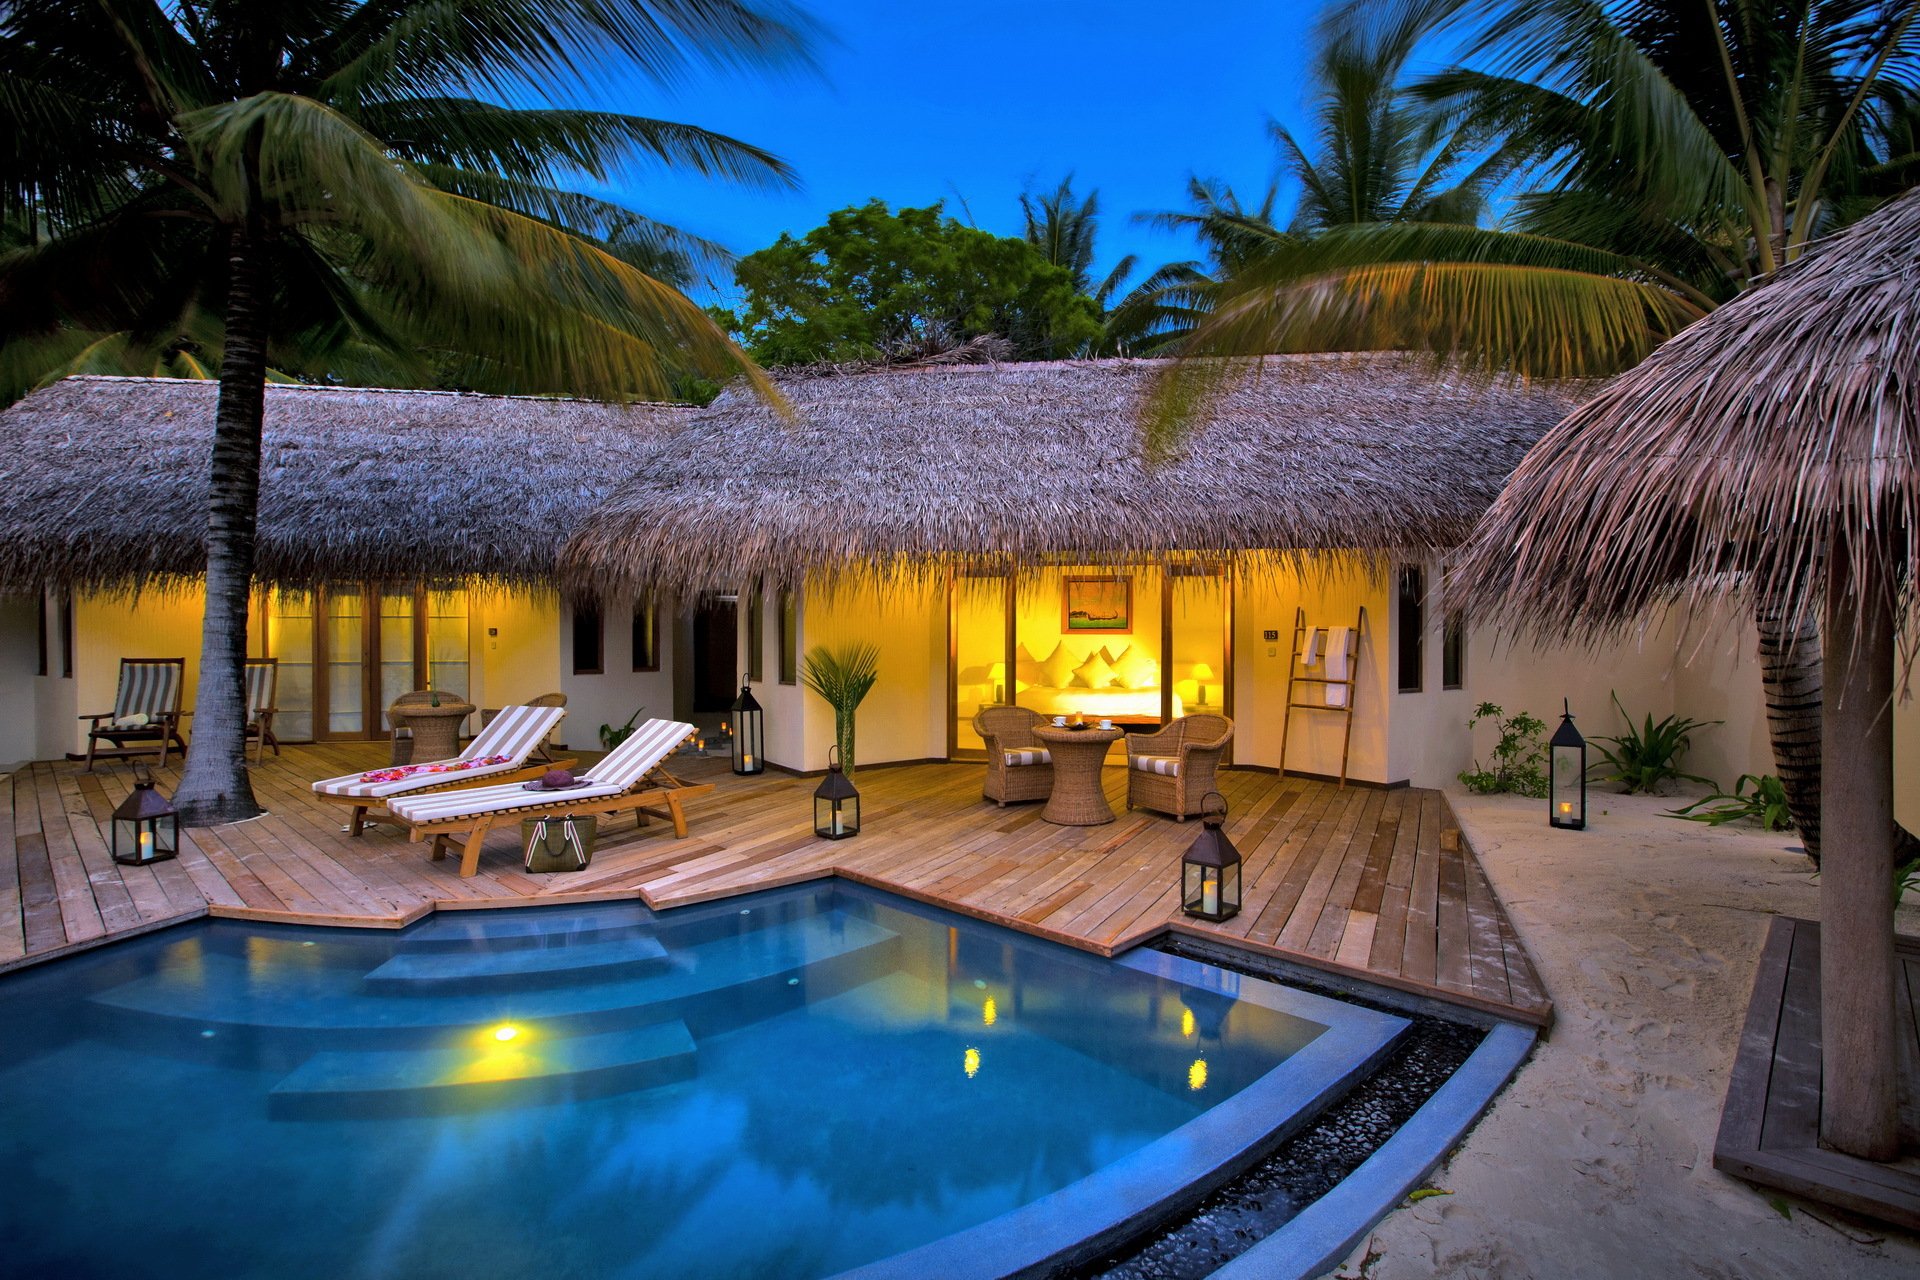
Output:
[[591, 0, 1319, 305]]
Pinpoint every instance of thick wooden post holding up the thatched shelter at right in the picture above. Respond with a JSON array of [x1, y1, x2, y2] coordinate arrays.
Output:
[[1820, 533, 1901, 1159]]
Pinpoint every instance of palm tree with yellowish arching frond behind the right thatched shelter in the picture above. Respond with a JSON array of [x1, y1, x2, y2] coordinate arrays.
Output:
[[1188, 0, 1920, 860]]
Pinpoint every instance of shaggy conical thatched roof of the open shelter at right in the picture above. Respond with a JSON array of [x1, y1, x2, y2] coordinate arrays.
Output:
[[1455, 192, 1920, 635]]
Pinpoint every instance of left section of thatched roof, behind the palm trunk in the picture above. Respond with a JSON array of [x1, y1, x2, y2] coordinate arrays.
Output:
[[0, 378, 689, 589]]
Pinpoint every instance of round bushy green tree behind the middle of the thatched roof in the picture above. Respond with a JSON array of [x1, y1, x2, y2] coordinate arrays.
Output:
[[733, 200, 1100, 365]]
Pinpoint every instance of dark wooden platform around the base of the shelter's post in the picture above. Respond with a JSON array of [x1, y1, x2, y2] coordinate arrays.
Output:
[[1713, 915, 1920, 1230]]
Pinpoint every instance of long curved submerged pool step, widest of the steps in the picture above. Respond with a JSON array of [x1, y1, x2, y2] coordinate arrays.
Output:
[[90, 912, 899, 1067]]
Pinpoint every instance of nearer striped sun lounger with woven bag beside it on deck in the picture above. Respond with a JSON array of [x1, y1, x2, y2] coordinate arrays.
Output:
[[388, 720, 712, 877]]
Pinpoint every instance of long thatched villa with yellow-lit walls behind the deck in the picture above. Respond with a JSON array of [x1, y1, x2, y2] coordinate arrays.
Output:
[[0, 357, 1764, 802]]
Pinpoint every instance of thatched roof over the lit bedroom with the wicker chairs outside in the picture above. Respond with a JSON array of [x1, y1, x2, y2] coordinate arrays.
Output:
[[564, 357, 1572, 593]]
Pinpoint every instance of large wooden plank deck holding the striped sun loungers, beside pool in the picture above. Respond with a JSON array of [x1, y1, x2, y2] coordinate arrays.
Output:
[[0, 743, 1551, 1027]]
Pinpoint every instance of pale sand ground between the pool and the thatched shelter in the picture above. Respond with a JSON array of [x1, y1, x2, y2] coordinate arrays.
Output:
[[1334, 793, 1920, 1280]]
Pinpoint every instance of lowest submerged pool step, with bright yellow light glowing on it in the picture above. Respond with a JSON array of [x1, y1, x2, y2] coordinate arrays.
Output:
[[267, 1021, 695, 1119]]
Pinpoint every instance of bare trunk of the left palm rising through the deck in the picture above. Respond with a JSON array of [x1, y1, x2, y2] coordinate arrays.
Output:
[[173, 226, 267, 827]]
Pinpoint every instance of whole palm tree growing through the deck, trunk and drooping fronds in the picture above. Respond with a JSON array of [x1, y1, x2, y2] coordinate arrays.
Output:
[[0, 0, 804, 823]]
